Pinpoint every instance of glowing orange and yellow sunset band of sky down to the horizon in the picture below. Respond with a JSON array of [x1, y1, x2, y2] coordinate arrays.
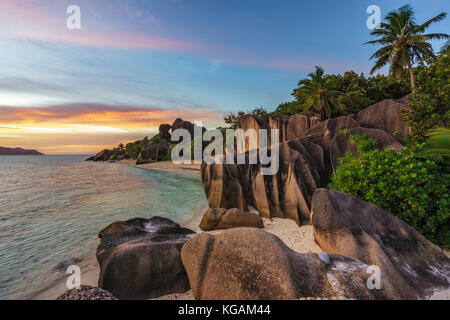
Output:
[[0, 104, 222, 154]]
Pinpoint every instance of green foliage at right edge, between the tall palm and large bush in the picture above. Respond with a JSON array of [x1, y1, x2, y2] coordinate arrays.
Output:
[[405, 48, 450, 145]]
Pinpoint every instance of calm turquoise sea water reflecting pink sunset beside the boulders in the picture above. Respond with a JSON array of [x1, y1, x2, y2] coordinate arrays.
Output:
[[0, 156, 207, 299]]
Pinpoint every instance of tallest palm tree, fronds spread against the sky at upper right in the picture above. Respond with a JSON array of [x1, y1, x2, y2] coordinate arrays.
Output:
[[365, 5, 449, 88]]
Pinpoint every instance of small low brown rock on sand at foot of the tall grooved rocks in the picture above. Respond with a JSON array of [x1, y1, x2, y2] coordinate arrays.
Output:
[[200, 208, 264, 231]]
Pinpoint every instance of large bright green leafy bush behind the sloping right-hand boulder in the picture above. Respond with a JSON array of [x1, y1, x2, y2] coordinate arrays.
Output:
[[328, 135, 450, 249]]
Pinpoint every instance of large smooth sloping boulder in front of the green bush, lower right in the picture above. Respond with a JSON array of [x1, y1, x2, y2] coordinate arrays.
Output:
[[311, 189, 450, 299]]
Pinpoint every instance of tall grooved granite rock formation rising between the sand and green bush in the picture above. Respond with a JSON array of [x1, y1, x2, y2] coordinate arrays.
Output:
[[201, 100, 409, 224]]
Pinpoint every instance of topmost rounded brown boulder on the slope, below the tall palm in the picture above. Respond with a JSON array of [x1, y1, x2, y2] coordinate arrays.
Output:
[[356, 99, 411, 142]]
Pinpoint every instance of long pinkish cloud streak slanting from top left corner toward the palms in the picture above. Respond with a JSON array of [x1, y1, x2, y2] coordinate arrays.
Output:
[[0, 0, 354, 72]]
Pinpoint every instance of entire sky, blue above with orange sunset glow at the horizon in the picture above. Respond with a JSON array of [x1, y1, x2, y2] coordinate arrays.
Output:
[[0, 0, 450, 154]]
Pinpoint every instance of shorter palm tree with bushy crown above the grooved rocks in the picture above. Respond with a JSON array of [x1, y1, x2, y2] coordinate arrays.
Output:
[[296, 66, 344, 120]]
